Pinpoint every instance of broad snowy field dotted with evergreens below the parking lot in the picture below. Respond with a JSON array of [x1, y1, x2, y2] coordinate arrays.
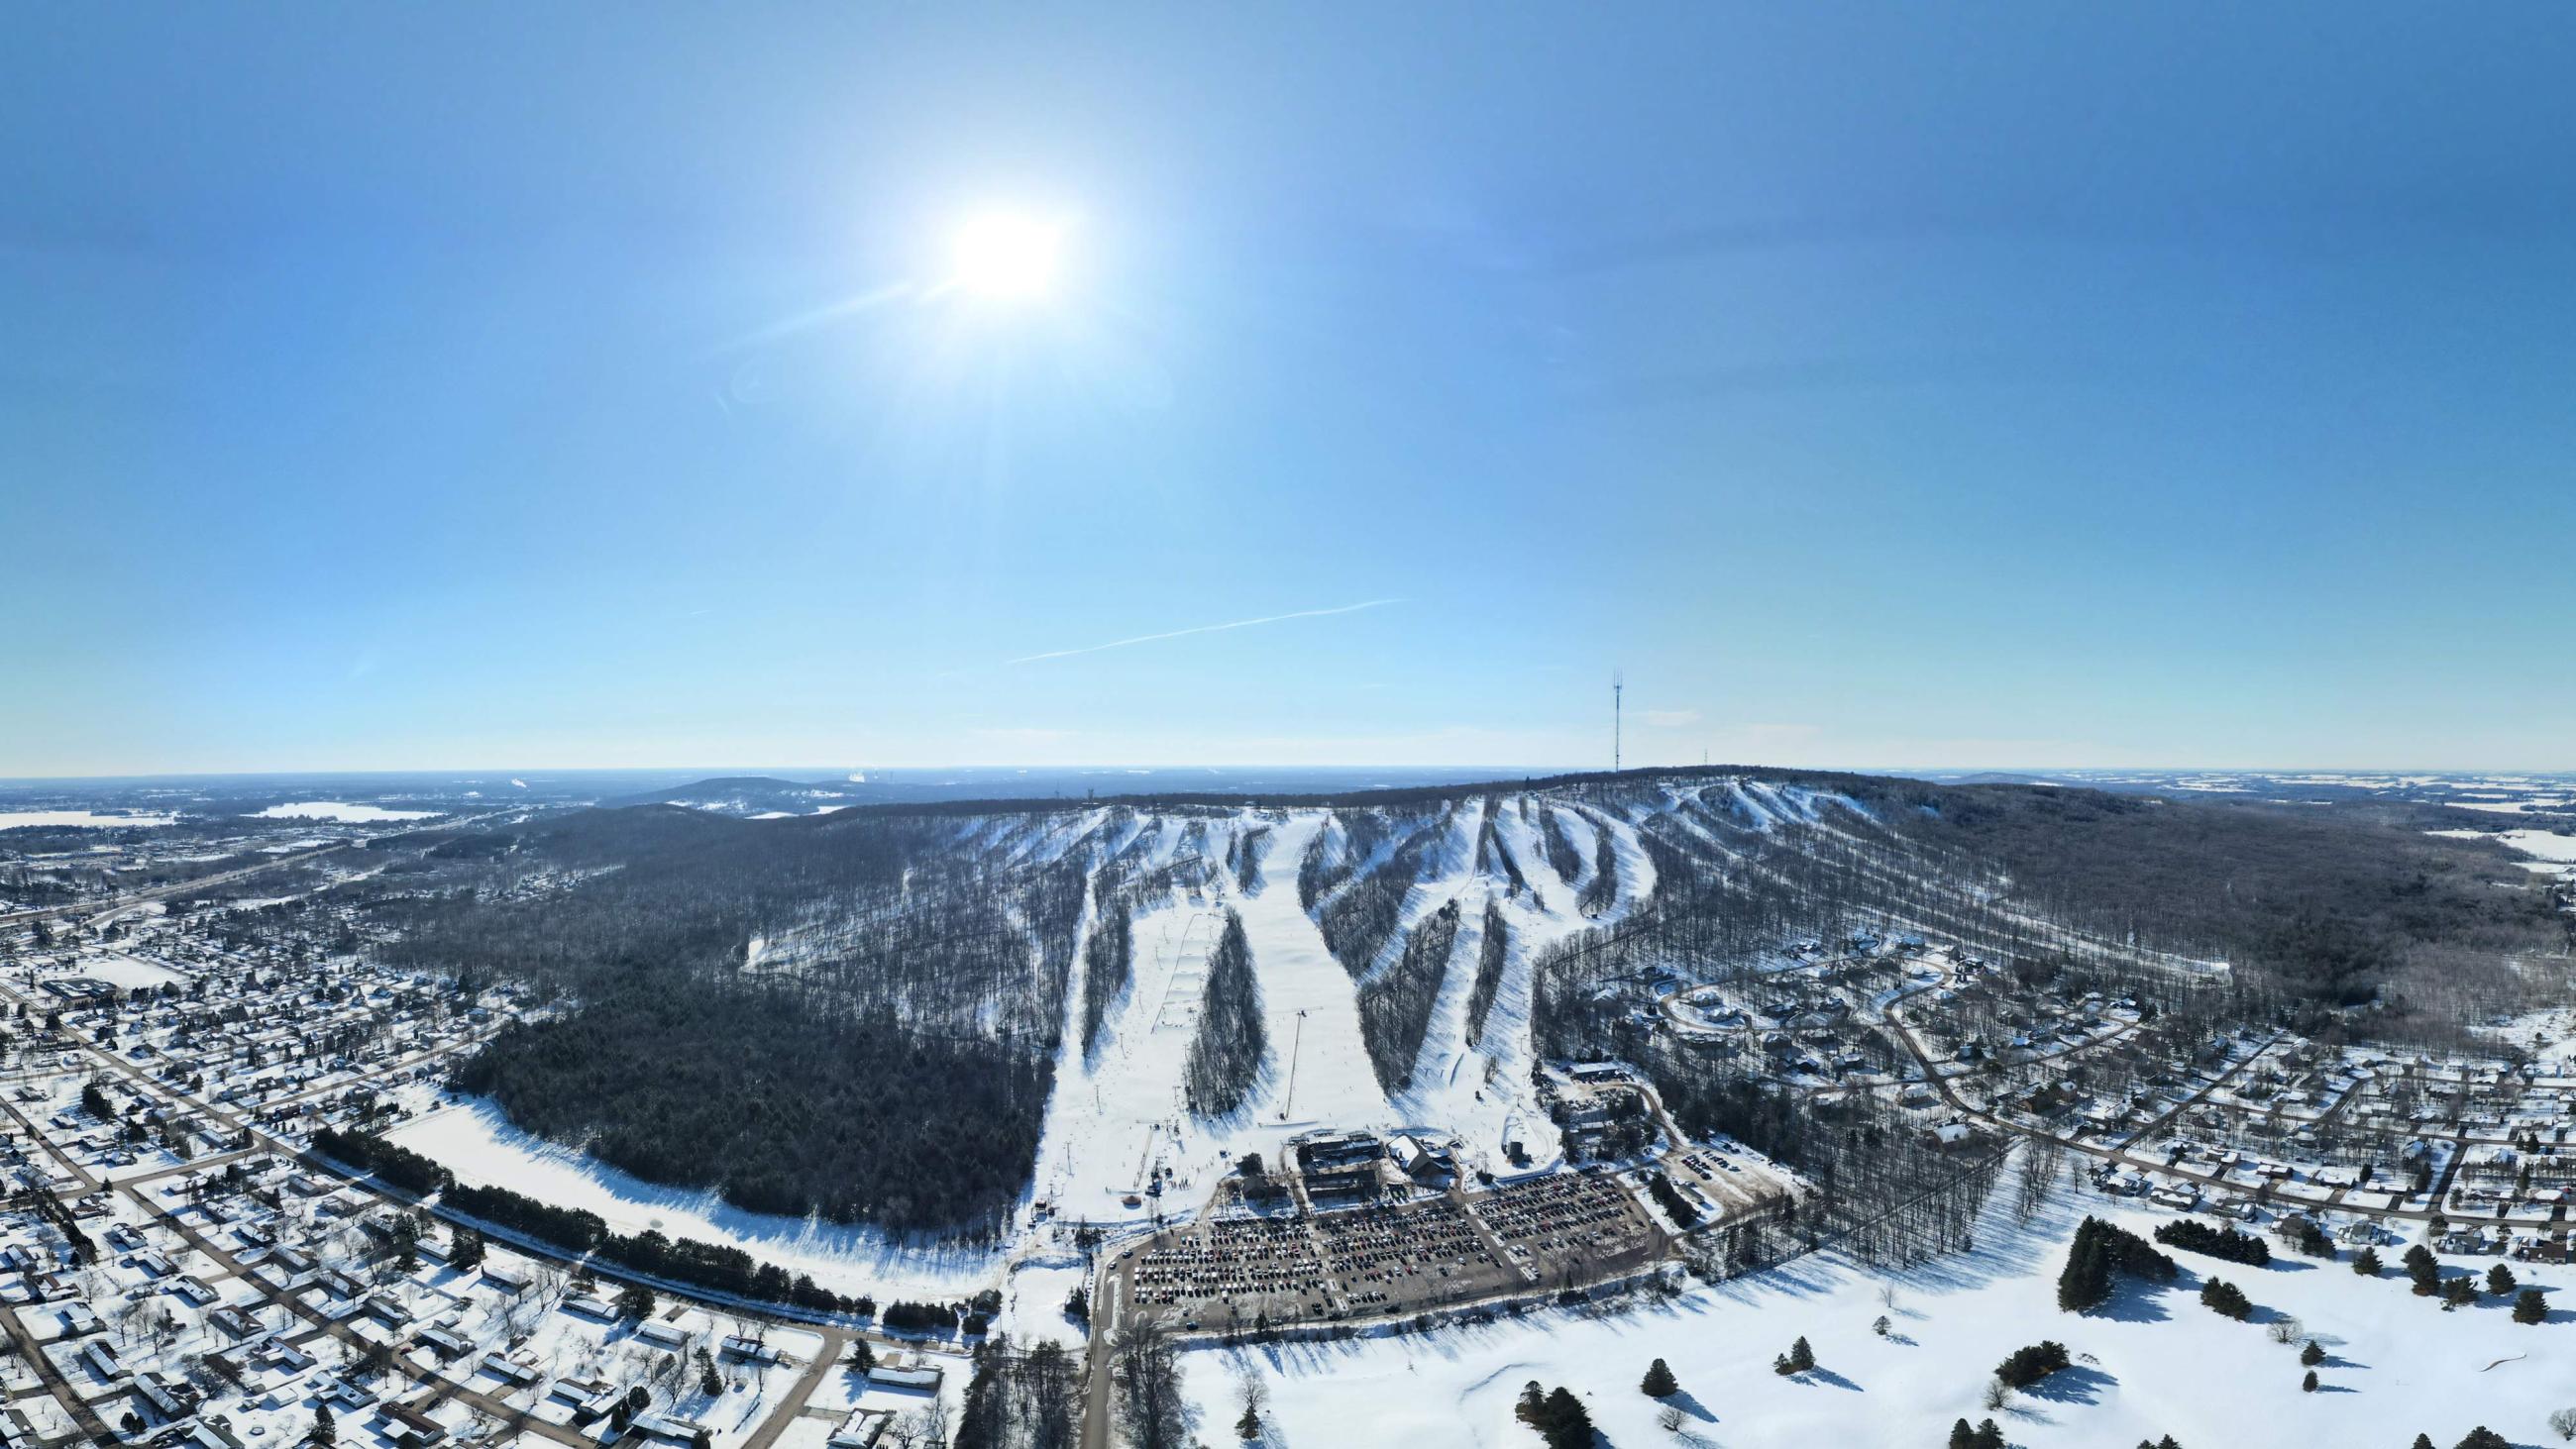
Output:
[[1185, 1158, 2576, 1449]]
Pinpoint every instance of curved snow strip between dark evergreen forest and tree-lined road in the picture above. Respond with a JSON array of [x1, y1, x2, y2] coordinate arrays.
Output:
[[391, 1099, 1002, 1299]]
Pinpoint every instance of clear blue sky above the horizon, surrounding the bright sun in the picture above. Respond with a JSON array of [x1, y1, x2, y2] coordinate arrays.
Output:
[[0, 0, 2576, 775]]
